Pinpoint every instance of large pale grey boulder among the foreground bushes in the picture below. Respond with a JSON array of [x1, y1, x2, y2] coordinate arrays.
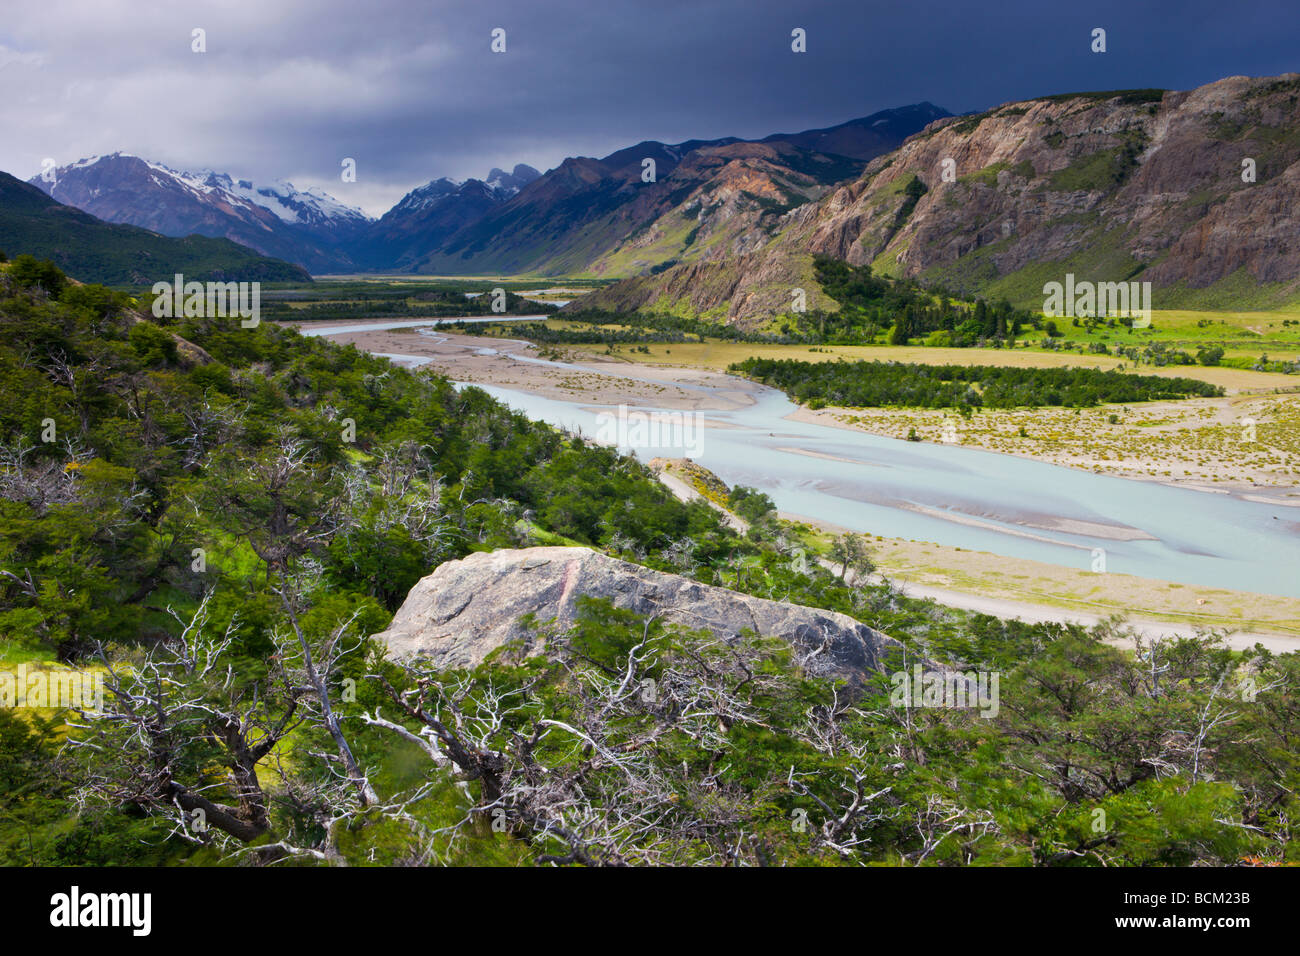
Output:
[[376, 548, 902, 683]]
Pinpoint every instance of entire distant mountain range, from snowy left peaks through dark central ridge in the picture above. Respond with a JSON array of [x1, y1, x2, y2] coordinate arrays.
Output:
[[20, 103, 946, 276]]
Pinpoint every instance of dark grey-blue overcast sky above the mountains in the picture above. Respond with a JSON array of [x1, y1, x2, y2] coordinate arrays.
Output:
[[0, 0, 1300, 215]]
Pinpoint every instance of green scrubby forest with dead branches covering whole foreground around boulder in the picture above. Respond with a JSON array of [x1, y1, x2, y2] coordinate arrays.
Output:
[[0, 258, 1300, 865]]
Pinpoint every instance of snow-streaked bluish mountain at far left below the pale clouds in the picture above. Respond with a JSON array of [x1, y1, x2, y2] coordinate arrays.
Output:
[[30, 152, 373, 272]]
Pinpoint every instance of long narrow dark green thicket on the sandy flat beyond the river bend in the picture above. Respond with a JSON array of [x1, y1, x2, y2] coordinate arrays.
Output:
[[728, 359, 1223, 408]]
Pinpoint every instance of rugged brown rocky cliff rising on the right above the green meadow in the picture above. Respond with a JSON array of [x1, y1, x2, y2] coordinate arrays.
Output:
[[573, 74, 1300, 324]]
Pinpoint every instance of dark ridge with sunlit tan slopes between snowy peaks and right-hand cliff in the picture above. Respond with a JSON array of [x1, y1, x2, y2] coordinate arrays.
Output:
[[395, 103, 948, 276]]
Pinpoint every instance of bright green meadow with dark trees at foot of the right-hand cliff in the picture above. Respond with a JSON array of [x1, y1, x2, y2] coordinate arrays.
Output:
[[553, 256, 1300, 373]]
